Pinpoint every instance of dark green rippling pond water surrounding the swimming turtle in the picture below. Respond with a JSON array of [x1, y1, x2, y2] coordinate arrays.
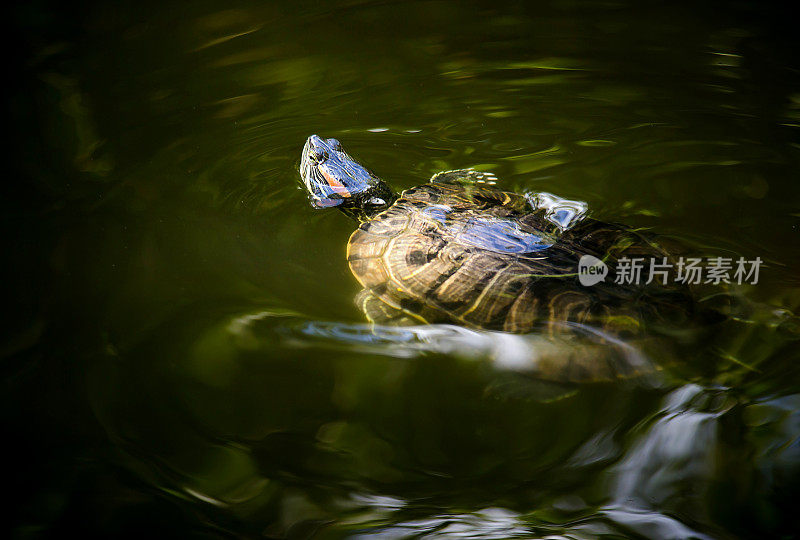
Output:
[[6, 1, 800, 538]]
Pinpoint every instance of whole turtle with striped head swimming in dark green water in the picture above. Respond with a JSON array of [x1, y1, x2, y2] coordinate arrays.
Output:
[[299, 135, 698, 382]]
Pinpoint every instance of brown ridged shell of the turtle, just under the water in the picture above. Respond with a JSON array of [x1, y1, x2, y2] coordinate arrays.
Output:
[[347, 184, 687, 335]]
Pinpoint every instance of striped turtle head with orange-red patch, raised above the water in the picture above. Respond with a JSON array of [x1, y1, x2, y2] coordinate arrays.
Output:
[[300, 135, 395, 218]]
